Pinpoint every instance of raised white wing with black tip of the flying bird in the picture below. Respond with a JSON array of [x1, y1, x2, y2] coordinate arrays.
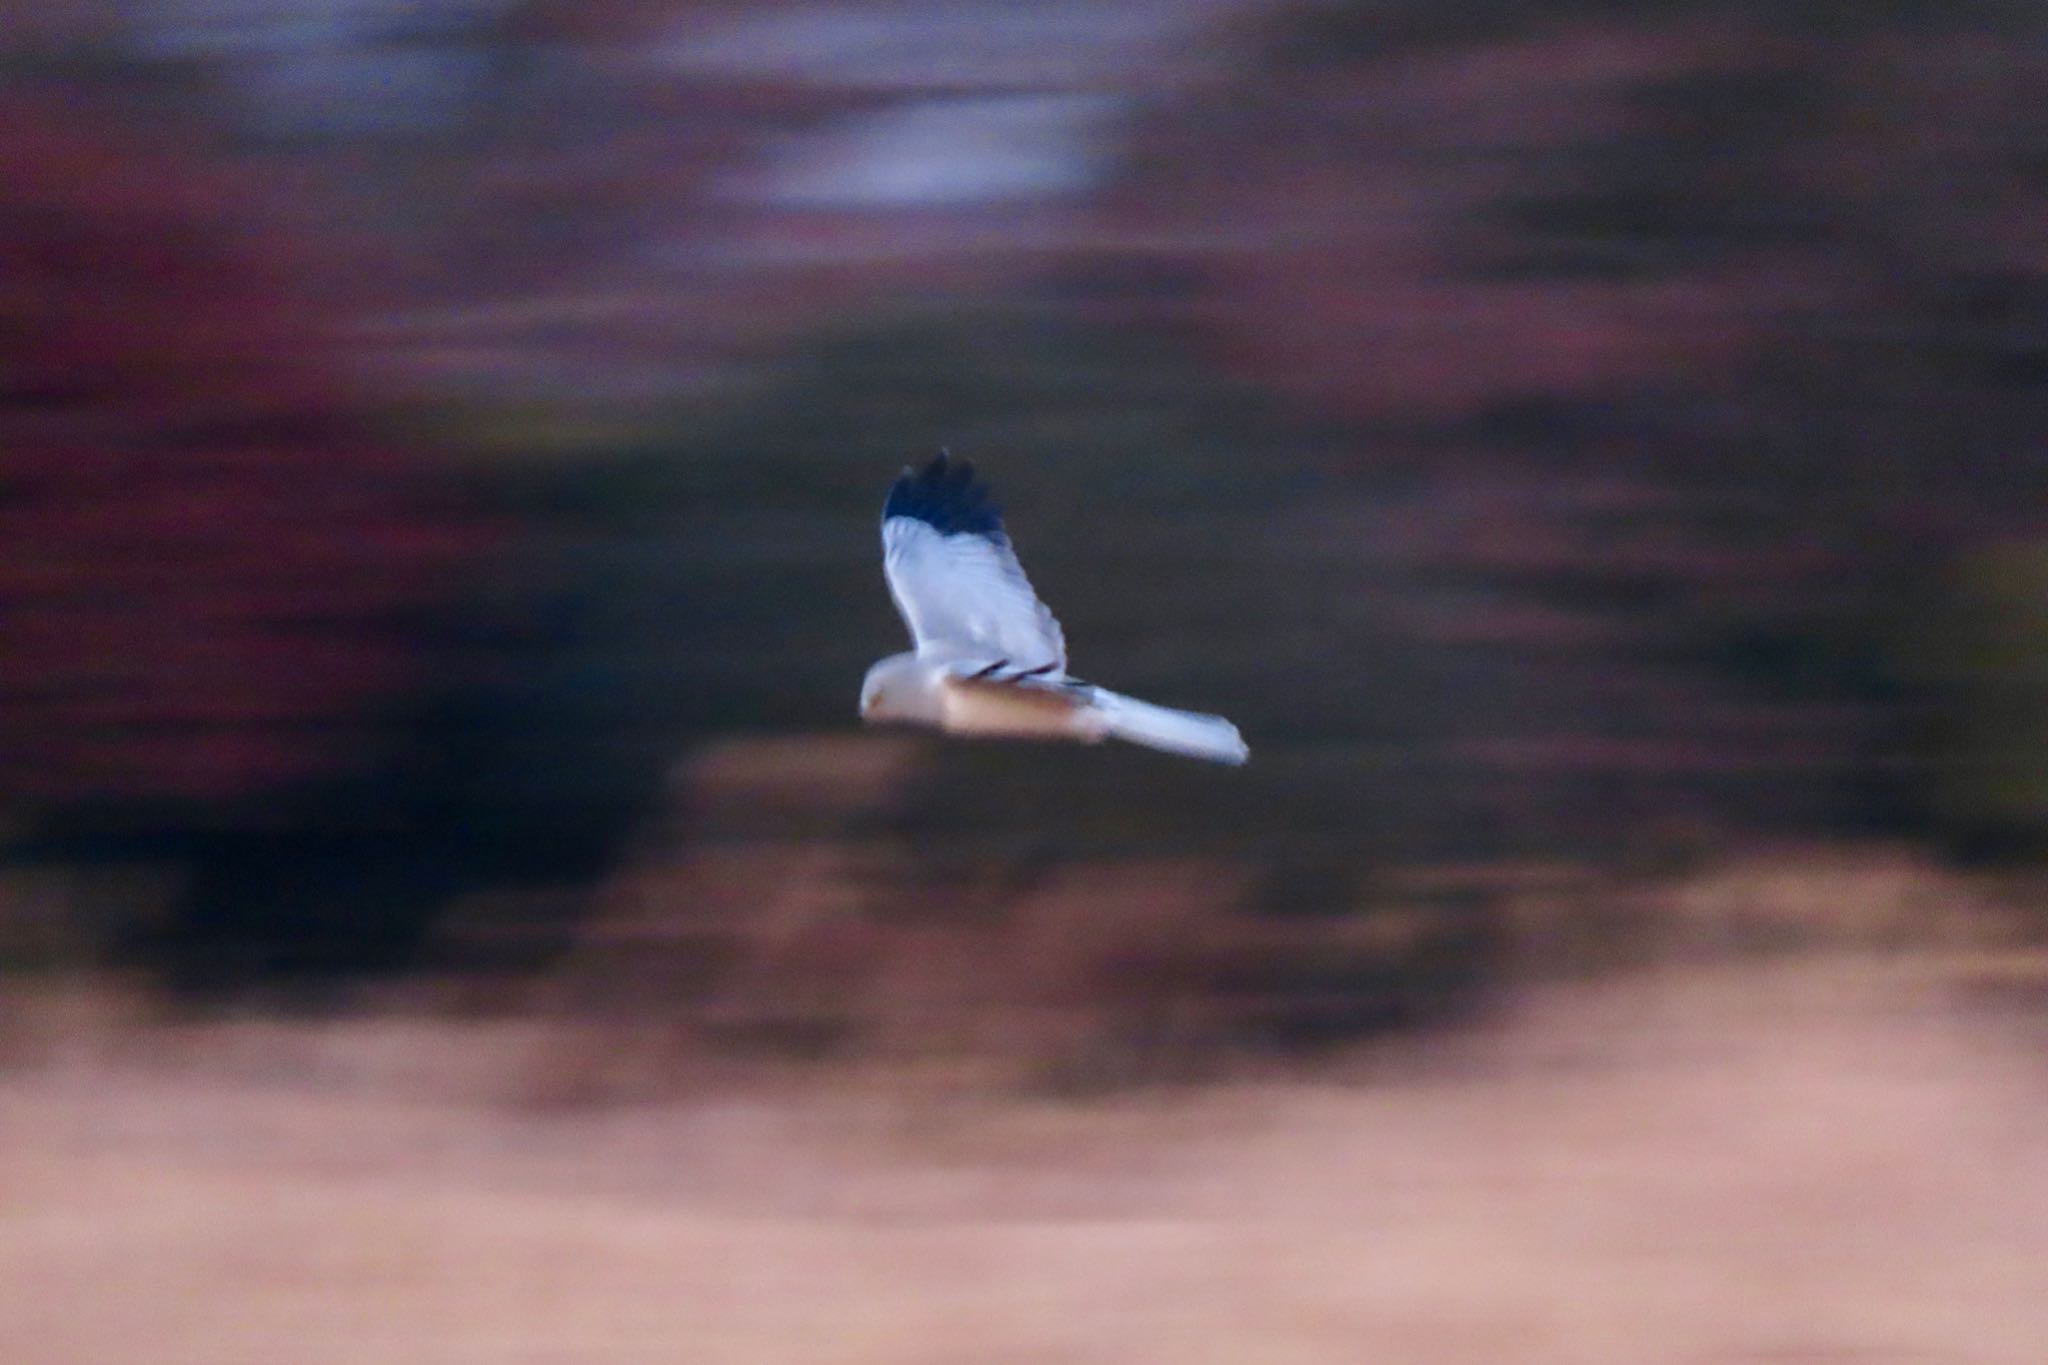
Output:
[[883, 452, 1067, 679]]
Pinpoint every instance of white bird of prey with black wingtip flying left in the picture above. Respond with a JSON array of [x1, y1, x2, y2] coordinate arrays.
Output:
[[860, 450, 1251, 763]]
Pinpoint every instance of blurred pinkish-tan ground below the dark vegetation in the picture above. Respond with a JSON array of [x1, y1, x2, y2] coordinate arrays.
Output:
[[0, 952, 2048, 1365]]
